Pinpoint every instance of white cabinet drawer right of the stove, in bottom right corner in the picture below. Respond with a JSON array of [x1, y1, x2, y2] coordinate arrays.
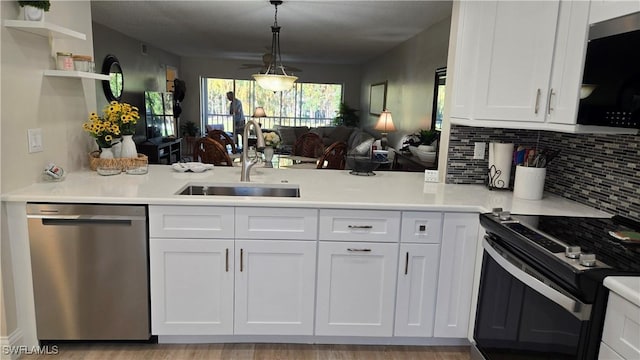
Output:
[[602, 292, 640, 359]]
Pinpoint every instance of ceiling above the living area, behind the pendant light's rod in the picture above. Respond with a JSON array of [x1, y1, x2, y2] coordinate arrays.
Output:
[[91, 0, 451, 64]]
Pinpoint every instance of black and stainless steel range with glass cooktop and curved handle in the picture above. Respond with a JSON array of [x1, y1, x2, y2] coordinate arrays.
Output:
[[474, 210, 640, 360]]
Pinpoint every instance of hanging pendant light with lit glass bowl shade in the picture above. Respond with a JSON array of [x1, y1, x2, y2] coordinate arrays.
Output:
[[252, 0, 298, 91]]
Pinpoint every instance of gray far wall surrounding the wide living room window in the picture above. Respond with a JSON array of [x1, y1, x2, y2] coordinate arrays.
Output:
[[178, 57, 361, 129]]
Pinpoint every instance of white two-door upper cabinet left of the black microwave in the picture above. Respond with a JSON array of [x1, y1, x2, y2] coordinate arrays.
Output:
[[451, 0, 635, 133]]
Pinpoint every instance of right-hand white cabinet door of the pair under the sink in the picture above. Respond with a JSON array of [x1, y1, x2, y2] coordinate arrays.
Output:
[[234, 240, 316, 335]]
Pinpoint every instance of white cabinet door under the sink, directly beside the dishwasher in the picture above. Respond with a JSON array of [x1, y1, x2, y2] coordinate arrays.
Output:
[[149, 238, 233, 335]]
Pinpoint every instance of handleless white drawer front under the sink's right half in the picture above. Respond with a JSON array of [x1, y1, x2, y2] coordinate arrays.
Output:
[[236, 207, 318, 240]]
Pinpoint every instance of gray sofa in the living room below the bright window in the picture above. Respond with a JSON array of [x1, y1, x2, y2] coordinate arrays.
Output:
[[274, 125, 380, 155]]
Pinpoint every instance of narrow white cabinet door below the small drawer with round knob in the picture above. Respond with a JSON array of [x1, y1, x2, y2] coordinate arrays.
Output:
[[394, 244, 440, 337]]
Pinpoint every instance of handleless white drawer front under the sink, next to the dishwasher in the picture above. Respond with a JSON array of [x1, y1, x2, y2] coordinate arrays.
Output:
[[149, 206, 234, 239]]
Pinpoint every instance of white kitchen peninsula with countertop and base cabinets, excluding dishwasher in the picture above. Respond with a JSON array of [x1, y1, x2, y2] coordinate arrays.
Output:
[[3, 165, 608, 345]]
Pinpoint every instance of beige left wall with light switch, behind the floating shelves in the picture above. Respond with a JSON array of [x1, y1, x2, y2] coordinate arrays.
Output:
[[0, 0, 96, 336]]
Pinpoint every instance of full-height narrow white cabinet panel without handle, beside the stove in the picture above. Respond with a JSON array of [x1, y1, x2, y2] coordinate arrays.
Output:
[[433, 213, 479, 338]]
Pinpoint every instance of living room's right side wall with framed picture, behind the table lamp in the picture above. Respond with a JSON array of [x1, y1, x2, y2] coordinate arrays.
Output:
[[360, 17, 451, 147]]
